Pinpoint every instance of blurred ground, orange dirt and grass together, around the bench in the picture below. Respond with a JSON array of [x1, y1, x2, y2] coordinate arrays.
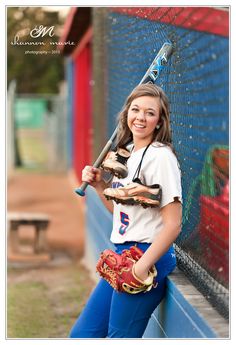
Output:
[[7, 172, 94, 338]]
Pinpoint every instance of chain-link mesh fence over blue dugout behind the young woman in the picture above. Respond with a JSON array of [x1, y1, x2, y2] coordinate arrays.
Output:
[[93, 7, 229, 318]]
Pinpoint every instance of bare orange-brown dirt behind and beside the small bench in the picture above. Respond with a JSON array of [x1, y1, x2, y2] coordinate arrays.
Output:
[[7, 172, 84, 257]]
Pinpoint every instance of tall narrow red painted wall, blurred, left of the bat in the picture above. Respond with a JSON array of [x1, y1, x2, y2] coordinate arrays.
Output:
[[73, 43, 92, 181]]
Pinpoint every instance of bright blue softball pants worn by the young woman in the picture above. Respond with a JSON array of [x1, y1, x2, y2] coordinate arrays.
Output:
[[70, 242, 176, 338]]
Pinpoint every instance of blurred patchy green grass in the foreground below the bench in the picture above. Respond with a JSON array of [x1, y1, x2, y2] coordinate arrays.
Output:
[[7, 265, 93, 338]]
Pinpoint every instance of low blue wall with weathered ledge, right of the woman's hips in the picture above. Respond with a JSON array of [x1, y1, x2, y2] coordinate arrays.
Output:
[[143, 269, 229, 339]]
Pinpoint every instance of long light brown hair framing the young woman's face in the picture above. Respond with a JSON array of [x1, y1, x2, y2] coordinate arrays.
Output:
[[116, 84, 174, 151]]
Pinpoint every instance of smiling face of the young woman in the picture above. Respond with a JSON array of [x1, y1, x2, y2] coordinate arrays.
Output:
[[127, 96, 160, 145]]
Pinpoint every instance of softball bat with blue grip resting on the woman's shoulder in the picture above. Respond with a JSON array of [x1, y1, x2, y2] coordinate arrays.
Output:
[[75, 42, 173, 196]]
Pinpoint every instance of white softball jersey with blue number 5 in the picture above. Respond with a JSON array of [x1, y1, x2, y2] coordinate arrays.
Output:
[[111, 142, 182, 243]]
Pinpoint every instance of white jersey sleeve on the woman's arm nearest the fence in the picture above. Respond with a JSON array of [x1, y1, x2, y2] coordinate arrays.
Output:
[[153, 148, 182, 207]]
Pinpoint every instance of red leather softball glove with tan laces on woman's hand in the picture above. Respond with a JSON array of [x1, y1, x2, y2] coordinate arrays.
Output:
[[96, 246, 157, 294]]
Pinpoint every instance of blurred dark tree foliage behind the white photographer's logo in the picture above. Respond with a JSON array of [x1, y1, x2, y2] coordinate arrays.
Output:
[[7, 7, 64, 93]]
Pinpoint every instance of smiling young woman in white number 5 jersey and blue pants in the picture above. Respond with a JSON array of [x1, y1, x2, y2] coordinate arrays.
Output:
[[70, 84, 182, 338]]
